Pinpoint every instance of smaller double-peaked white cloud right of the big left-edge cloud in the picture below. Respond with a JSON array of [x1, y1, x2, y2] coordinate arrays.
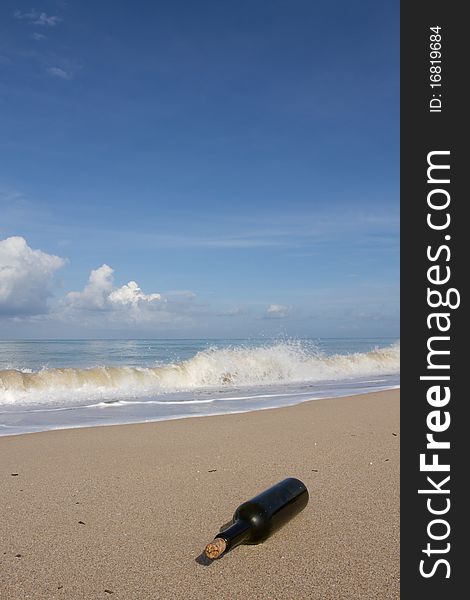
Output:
[[65, 264, 161, 319]]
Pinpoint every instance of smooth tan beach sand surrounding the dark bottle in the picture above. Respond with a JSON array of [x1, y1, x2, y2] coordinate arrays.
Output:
[[0, 390, 399, 600]]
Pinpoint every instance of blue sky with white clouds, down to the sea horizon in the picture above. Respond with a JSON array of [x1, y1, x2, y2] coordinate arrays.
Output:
[[0, 0, 399, 338]]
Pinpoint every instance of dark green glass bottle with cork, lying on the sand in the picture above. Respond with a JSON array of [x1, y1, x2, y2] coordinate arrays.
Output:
[[205, 477, 308, 558]]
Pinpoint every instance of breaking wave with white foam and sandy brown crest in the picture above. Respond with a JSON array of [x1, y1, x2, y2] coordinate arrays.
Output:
[[0, 342, 400, 404]]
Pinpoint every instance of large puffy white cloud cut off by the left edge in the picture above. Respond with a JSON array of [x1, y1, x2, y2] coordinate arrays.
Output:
[[0, 236, 66, 316]]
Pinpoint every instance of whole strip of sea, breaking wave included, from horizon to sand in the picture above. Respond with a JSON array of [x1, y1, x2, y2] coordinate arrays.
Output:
[[0, 338, 400, 435]]
